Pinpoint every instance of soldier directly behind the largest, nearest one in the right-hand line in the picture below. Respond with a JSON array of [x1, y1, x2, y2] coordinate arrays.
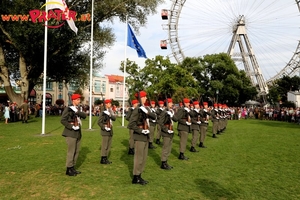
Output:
[[157, 98, 177, 170]]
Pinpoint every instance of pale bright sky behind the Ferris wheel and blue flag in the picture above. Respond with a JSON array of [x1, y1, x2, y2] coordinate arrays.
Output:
[[101, 0, 300, 80]]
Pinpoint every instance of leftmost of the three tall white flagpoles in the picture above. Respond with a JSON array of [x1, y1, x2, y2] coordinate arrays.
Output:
[[38, 0, 48, 135]]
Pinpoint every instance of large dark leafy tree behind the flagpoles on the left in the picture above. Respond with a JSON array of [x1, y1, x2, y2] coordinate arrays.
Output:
[[0, 0, 162, 103]]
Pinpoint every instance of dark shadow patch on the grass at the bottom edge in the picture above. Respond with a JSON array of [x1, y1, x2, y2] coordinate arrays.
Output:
[[195, 179, 238, 199]]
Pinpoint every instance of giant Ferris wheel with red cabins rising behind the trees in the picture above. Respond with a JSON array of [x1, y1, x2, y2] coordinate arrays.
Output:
[[161, 0, 300, 93]]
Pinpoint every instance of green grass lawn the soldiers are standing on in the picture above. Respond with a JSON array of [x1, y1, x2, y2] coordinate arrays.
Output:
[[0, 116, 300, 200]]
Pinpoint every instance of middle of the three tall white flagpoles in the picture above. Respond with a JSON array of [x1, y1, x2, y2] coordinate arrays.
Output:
[[89, 0, 94, 130]]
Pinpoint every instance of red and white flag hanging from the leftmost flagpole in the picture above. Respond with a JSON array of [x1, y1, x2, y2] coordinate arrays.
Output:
[[47, 0, 78, 34]]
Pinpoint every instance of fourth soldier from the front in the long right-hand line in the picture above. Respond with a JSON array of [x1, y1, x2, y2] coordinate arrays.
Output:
[[190, 101, 201, 152]]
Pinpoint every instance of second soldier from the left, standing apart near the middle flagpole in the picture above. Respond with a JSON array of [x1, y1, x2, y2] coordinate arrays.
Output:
[[98, 99, 116, 164]]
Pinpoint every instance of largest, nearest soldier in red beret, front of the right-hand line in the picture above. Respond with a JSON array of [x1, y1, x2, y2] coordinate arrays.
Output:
[[128, 91, 156, 185]]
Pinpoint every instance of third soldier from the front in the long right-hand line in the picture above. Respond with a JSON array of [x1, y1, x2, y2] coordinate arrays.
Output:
[[175, 98, 192, 160]]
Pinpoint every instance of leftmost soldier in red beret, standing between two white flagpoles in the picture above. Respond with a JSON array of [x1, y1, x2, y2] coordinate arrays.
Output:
[[60, 94, 86, 176]]
